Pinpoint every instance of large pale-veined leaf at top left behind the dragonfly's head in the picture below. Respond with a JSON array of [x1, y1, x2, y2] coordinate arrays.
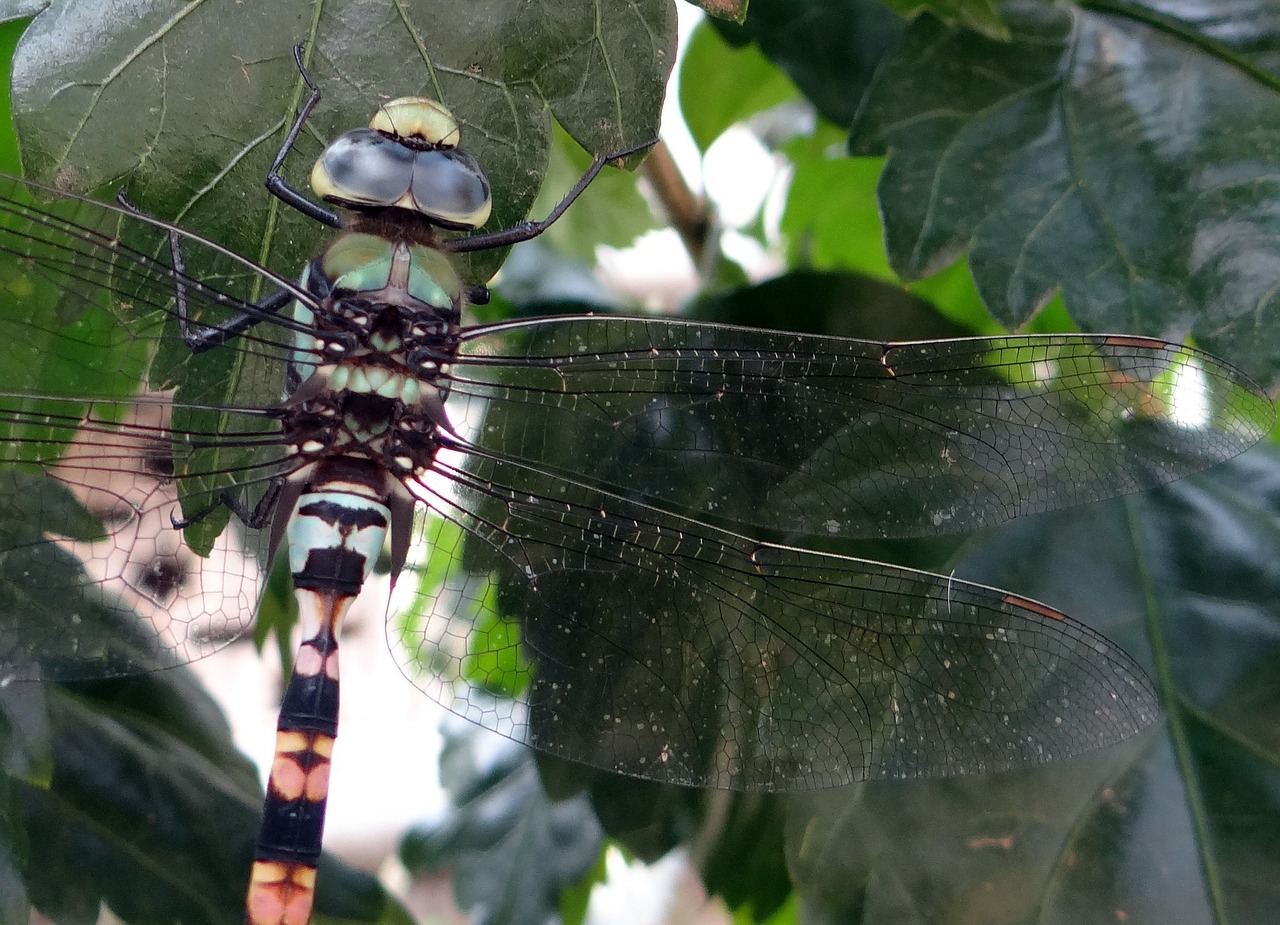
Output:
[[0, 0, 675, 281]]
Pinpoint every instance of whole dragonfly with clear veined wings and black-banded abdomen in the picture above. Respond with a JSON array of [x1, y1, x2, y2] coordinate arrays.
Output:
[[0, 52, 1274, 925]]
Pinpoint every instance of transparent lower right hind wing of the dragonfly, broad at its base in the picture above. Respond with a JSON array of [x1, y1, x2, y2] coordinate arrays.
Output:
[[396, 458, 1158, 791]]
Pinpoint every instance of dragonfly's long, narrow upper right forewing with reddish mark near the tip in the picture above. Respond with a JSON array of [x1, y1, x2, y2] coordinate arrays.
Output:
[[451, 317, 1274, 537]]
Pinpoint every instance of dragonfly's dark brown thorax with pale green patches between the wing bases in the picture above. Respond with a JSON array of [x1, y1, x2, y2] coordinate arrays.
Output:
[[278, 223, 462, 540]]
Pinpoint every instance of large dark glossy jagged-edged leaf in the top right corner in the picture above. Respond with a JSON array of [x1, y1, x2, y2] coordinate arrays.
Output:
[[852, 3, 1280, 383]]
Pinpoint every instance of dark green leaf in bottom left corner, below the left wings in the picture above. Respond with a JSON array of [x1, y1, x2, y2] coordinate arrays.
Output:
[[4, 670, 388, 922]]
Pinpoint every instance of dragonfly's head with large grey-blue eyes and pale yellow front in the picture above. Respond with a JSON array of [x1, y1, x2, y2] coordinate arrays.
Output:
[[311, 96, 493, 230]]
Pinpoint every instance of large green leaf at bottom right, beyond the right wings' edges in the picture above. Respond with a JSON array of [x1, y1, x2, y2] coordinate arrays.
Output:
[[788, 449, 1280, 925]]
